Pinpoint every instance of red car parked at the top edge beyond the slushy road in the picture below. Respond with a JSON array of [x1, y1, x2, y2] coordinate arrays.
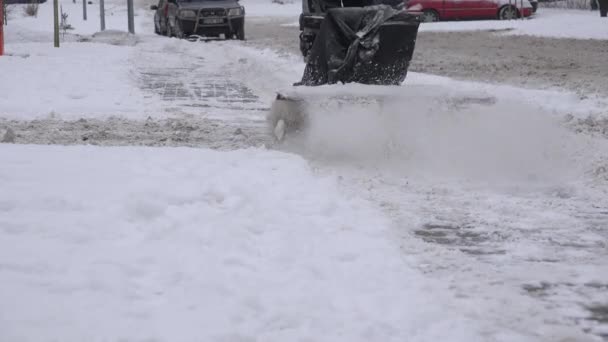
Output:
[[407, 0, 534, 22]]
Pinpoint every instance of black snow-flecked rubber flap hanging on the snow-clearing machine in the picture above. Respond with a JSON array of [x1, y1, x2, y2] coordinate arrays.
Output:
[[295, 4, 420, 86]]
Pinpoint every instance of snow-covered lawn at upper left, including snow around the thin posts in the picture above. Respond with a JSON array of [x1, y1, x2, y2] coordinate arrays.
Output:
[[0, 0, 150, 119]]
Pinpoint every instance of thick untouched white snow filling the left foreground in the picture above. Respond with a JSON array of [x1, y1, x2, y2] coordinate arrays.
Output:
[[0, 145, 486, 342]]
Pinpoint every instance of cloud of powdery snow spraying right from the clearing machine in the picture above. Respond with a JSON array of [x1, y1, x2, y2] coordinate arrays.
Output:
[[288, 86, 588, 180]]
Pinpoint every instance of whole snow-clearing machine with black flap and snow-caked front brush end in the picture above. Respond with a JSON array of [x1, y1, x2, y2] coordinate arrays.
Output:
[[268, 0, 421, 141]]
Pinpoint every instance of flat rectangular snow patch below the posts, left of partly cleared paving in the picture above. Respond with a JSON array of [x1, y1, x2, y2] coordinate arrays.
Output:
[[0, 43, 143, 120]]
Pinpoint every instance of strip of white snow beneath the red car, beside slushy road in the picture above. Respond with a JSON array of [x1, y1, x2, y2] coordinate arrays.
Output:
[[420, 8, 608, 39]]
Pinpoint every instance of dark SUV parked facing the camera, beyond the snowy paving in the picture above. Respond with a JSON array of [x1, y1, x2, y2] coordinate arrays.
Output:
[[150, 0, 245, 40]]
